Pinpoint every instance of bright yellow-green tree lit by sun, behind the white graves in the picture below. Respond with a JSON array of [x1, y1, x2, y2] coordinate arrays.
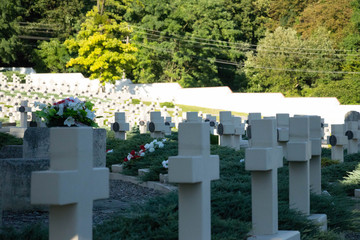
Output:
[[65, 7, 137, 83]]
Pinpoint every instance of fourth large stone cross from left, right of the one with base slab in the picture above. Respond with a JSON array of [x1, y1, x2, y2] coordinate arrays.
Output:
[[287, 116, 311, 215]]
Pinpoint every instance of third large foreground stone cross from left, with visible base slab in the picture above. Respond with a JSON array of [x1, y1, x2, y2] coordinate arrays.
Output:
[[245, 119, 300, 240]]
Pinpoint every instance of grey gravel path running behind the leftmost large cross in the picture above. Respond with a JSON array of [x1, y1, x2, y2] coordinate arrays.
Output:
[[2, 180, 162, 229]]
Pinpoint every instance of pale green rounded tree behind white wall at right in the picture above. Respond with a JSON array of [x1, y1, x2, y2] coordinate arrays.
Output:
[[244, 27, 340, 96]]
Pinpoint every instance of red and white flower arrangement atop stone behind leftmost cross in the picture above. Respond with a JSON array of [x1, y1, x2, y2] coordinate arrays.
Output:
[[34, 97, 98, 127]]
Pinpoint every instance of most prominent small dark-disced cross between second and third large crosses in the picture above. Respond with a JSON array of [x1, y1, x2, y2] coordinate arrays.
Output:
[[217, 111, 235, 147]]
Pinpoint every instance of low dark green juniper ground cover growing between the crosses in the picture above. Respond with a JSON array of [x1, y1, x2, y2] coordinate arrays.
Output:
[[0, 130, 360, 240]]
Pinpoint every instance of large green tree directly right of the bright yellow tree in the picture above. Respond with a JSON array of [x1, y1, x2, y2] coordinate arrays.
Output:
[[127, 0, 264, 90]]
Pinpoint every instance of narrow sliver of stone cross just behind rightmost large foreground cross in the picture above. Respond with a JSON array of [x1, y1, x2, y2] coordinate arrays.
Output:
[[309, 116, 322, 194]]
